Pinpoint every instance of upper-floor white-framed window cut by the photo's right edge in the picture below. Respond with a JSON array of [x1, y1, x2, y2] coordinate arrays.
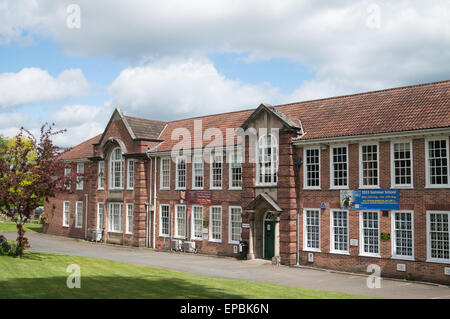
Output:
[[425, 137, 450, 188]]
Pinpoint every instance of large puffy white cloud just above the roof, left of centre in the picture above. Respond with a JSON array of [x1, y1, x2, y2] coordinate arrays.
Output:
[[109, 58, 279, 120]]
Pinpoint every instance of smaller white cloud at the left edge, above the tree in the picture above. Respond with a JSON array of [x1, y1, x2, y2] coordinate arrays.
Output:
[[0, 68, 89, 108]]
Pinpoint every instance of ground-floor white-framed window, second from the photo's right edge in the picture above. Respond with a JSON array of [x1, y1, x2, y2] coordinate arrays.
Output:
[[391, 211, 414, 260]]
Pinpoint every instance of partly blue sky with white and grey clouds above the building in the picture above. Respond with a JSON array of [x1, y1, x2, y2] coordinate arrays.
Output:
[[0, 0, 450, 147]]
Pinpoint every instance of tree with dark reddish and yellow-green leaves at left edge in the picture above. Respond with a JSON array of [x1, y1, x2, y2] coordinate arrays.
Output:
[[0, 124, 77, 258]]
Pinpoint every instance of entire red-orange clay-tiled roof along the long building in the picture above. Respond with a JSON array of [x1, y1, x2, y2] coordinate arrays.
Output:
[[59, 80, 450, 158]]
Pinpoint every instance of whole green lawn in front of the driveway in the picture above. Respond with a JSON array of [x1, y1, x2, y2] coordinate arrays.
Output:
[[0, 251, 370, 299]]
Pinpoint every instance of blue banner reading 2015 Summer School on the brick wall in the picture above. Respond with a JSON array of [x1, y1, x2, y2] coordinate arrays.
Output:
[[340, 189, 399, 210]]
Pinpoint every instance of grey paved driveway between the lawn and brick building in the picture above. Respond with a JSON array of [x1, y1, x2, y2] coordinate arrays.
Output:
[[0, 233, 450, 299]]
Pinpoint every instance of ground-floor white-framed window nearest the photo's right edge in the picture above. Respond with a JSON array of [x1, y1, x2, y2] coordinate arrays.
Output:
[[427, 211, 450, 264]]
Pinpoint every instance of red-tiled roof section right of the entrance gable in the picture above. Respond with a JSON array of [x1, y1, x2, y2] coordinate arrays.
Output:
[[277, 81, 450, 140]]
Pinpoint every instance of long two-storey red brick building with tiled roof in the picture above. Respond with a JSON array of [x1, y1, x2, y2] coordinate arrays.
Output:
[[45, 81, 450, 283]]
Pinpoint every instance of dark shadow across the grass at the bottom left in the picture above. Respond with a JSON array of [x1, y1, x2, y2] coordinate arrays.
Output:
[[0, 274, 245, 299]]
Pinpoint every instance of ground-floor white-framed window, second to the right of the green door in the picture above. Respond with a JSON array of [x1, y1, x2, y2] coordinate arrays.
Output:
[[330, 209, 349, 254]]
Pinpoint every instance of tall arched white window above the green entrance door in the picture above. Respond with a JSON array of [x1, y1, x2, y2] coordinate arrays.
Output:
[[256, 134, 278, 185]]
